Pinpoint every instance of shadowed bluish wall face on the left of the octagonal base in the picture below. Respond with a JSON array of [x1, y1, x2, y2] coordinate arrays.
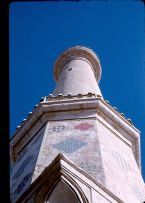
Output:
[[10, 127, 45, 202]]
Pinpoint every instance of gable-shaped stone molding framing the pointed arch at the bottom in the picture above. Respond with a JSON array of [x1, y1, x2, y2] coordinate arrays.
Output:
[[16, 154, 123, 203]]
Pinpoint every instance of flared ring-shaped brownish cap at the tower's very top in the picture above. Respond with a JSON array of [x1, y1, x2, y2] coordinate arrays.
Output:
[[54, 46, 102, 82]]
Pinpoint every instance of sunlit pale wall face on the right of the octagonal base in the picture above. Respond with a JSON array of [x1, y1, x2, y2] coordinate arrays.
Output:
[[97, 119, 145, 203]]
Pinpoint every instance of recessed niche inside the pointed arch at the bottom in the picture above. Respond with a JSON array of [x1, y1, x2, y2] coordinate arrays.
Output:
[[46, 180, 80, 203]]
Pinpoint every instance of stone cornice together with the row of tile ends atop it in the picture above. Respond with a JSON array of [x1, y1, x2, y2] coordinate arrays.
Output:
[[11, 93, 140, 141]]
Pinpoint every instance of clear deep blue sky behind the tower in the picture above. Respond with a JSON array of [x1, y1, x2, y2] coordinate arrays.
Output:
[[9, 0, 145, 179]]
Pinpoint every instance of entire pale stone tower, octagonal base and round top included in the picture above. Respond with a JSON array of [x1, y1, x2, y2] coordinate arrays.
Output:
[[11, 46, 145, 203]]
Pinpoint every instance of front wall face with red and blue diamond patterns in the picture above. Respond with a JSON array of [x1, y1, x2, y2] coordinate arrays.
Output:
[[34, 119, 105, 185]]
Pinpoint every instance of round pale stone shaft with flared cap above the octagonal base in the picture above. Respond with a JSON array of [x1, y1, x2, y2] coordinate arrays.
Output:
[[53, 46, 102, 96]]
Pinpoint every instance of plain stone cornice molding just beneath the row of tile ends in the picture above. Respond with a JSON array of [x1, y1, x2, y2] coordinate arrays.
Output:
[[10, 97, 140, 167]]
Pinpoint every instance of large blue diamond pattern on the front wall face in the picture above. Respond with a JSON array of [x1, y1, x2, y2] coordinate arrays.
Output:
[[53, 138, 87, 153]]
